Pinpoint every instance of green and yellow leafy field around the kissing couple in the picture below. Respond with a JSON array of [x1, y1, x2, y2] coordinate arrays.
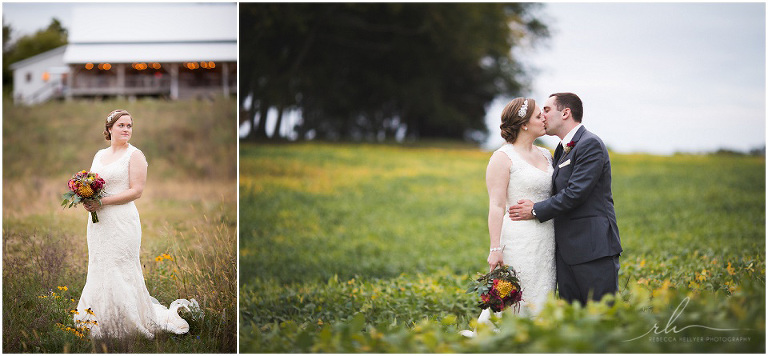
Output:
[[239, 143, 765, 353]]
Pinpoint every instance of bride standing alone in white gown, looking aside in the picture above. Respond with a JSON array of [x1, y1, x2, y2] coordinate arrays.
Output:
[[74, 110, 197, 338]]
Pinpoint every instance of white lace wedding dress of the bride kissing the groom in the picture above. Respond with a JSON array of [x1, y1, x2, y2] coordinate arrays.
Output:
[[462, 143, 555, 336]]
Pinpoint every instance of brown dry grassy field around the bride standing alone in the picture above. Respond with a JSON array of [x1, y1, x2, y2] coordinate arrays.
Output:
[[3, 98, 237, 353]]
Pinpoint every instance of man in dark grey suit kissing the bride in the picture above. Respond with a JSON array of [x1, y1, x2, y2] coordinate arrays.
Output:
[[509, 93, 622, 305]]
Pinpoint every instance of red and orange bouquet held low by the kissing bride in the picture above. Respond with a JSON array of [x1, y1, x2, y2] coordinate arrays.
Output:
[[467, 265, 523, 312]]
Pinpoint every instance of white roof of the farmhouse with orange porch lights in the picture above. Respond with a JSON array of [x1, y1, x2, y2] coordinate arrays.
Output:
[[64, 3, 237, 64]]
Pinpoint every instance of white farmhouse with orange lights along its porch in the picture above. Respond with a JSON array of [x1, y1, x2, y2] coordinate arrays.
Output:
[[12, 3, 237, 104]]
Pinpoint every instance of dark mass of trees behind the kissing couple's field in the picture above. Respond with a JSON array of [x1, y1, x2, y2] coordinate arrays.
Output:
[[240, 3, 548, 139]]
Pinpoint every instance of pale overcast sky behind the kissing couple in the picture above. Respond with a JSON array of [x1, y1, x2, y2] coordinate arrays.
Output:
[[486, 3, 766, 154]]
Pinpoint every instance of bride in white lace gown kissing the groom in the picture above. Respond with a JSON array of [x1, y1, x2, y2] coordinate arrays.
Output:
[[462, 98, 555, 336]]
